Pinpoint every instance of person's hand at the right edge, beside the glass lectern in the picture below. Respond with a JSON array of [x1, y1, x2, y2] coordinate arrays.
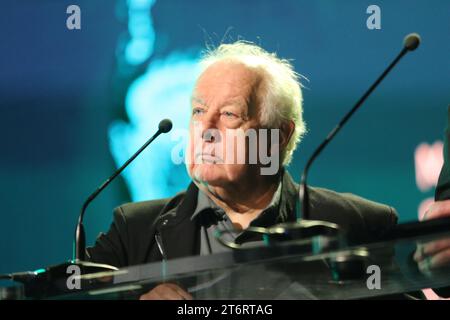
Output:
[[414, 200, 450, 273]]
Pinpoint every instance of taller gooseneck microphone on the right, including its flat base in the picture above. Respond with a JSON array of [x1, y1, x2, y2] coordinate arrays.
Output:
[[253, 33, 420, 248]]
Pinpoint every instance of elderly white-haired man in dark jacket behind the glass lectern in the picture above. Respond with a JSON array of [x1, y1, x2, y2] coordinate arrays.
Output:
[[87, 41, 450, 299]]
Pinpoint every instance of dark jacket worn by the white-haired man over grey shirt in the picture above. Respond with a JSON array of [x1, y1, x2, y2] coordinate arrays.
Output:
[[87, 173, 397, 267]]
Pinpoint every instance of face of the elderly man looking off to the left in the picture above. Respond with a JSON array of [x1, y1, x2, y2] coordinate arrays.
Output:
[[188, 62, 261, 187]]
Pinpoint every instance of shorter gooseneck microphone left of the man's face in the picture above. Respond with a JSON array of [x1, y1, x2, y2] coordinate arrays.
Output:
[[74, 119, 172, 261]]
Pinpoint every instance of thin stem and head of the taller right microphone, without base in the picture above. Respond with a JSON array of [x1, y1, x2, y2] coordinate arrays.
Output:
[[297, 33, 420, 220]]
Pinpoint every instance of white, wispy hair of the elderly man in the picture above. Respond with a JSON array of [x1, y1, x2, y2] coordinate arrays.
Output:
[[200, 40, 306, 166]]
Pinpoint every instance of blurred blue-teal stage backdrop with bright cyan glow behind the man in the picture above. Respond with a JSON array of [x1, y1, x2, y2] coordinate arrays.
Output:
[[0, 0, 450, 273]]
